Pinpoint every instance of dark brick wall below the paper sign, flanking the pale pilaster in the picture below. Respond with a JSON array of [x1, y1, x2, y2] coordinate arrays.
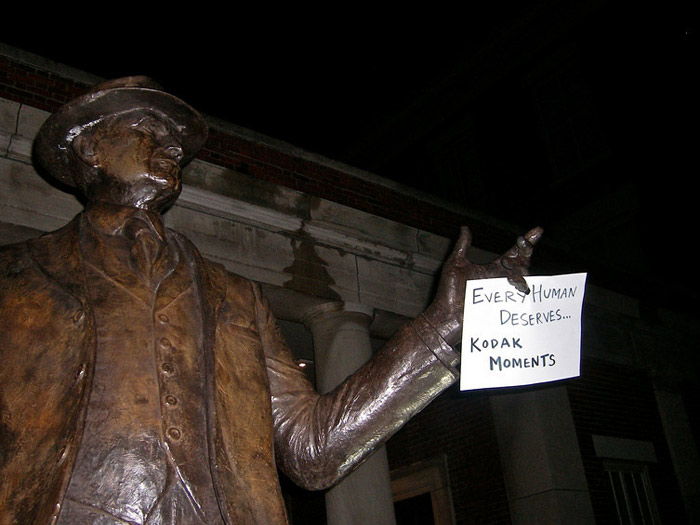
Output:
[[387, 358, 686, 525]]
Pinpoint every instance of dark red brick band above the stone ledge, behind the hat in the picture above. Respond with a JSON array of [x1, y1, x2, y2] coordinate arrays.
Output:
[[0, 56, 514, 252]]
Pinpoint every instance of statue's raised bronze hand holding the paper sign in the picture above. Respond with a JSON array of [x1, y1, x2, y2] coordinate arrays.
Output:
[[424, 226, 542, 345]]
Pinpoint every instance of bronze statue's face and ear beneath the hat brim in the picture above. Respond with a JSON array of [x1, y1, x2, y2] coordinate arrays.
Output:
[[80, 111, 183, 210]]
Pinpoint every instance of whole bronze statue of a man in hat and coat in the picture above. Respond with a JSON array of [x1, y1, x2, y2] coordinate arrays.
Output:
[[0, 77, 541, 525]]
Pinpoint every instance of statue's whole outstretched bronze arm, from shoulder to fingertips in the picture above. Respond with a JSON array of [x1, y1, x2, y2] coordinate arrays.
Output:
[[259, 228, 542, 489]]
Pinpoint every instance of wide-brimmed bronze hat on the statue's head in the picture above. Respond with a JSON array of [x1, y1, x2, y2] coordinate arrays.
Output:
[[34, 76, 208, 186]]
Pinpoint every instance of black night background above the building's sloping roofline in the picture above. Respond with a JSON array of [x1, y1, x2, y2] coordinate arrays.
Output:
[[0, 0, 699, 309]]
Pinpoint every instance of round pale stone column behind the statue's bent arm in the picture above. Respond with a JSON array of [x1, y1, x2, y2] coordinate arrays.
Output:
[[304, 303, 396, 525]]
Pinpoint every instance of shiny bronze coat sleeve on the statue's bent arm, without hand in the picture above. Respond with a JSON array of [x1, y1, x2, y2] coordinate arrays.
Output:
[[256, 287, 458, 490]]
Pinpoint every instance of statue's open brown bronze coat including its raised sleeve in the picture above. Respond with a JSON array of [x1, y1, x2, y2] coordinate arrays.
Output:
[[0, 215, 457, 525]]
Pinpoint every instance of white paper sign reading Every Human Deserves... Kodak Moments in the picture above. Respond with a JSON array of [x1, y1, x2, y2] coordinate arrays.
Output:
[[460, 273, 587, 390]]
